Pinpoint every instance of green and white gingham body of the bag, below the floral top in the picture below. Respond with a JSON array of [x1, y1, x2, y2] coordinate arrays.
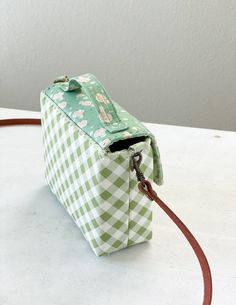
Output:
[[41, 93, 153, 256]]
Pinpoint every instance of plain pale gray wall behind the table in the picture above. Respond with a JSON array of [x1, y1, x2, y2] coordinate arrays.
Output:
[[0, 0, 236, 130]]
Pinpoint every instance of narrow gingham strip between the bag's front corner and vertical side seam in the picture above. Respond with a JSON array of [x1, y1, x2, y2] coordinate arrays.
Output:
[[97, 150, 129, 253]]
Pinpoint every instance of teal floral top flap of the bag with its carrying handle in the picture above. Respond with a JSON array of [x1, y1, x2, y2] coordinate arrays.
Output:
[[43, 73, 163, 184]]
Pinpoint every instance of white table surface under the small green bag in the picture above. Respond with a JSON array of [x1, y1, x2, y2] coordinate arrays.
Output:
[[0, 108, 236, 305]]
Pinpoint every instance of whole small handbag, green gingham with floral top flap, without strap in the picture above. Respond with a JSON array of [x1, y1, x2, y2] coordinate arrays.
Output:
[[41, 74, 162, 256]]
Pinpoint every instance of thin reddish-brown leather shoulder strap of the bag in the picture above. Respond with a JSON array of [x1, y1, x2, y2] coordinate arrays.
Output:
[[0, 118, 212, 305]]
